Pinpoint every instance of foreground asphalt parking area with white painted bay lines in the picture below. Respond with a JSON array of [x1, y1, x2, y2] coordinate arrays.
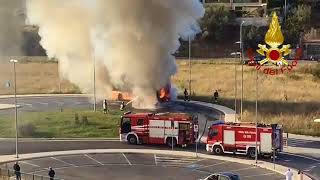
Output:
[[3, 153, 284, 180]]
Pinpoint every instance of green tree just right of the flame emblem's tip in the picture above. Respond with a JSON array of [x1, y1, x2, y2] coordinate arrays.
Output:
[[283, 4, 311, 44]]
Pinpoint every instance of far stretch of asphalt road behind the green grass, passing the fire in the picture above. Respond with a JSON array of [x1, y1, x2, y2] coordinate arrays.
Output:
[[0, 97, 222, 118]]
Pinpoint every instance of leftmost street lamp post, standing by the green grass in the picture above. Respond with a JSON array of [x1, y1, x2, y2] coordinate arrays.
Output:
[[10, 59, 19, 158]]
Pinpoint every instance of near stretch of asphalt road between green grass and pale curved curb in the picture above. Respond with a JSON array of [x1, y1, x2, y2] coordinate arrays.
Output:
[[0, 140, 320, 179]]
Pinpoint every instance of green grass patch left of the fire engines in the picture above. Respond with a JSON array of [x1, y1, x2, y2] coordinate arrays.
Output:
[[0, 110, 122, 138]]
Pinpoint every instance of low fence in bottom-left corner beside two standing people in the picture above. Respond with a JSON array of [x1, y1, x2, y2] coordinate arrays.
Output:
[[0, 168, 63, 180]]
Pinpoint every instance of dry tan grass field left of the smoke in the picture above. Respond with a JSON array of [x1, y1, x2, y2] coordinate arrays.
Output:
[[0, 57, 80, 94]]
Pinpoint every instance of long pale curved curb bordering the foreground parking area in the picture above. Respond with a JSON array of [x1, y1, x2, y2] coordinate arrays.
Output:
[[0, 149, 312, 180]]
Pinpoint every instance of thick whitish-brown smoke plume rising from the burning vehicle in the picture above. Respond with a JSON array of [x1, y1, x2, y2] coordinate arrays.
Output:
[[27, 0, 204, 106]]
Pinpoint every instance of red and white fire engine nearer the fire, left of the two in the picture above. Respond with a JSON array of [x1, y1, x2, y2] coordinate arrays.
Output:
[[119, 112, 198, 147]]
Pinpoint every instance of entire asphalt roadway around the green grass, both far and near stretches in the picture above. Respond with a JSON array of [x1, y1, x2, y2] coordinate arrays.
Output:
[[0, 97, 320, 179]]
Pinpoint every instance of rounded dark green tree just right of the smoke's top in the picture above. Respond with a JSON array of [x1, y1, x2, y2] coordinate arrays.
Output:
[[200, 5, 233, 40]]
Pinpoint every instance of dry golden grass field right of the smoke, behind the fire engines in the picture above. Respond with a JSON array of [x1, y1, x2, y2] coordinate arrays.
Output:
[[173, 60, 320, 136]]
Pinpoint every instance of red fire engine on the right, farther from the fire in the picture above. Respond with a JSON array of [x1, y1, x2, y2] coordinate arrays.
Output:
[[206, 122, 283, 158]]
